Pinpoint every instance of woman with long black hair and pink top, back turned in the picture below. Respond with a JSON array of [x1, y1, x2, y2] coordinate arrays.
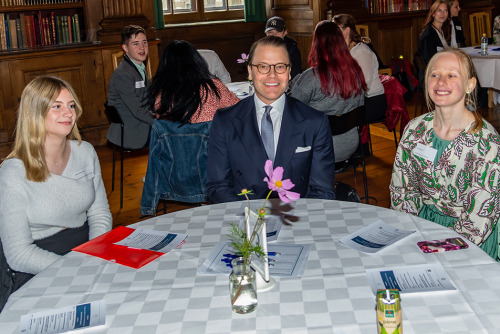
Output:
[[149, 41, 239, 124]]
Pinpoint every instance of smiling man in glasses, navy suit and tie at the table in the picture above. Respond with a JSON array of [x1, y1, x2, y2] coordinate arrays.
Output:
[[207, 36, 335, 203]]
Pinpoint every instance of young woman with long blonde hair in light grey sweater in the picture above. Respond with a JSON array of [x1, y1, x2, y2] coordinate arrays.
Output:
[[0, 76, 112, 309]]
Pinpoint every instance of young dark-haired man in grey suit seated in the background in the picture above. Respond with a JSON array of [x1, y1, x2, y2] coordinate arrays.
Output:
[[106, 25, 154, 149]]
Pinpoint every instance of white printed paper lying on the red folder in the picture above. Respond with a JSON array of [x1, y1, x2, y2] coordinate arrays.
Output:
[[114, 229, 187, 253]]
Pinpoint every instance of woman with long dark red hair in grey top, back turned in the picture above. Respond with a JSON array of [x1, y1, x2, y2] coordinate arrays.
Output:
[[290, 21, 366, 162]]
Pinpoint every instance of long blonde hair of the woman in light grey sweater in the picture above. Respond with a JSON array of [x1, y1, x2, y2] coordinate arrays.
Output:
[[7, 76, 82, 182]]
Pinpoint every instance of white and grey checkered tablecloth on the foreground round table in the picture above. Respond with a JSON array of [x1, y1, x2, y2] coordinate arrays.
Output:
[[0, 199, 500, 334]]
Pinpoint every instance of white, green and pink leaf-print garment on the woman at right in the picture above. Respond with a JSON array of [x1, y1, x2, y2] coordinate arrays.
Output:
[[389, 112, 500, 259]]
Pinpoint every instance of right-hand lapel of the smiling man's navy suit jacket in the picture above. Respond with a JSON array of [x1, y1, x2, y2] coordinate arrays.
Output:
[[274, 97, 308, 170]]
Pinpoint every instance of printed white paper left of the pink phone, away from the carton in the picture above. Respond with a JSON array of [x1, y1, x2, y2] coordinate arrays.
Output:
[[340, 220, 415, 253]]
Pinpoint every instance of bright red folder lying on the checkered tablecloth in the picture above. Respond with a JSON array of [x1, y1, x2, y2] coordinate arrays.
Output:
[[73, 226, 163, 269]]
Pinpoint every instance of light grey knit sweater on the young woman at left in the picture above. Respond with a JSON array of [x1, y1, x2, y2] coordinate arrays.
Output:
[[0, 141, 112, 274]]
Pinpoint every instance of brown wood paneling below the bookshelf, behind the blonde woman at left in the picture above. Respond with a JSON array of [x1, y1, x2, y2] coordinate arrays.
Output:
[[0, 40, 160, 157]]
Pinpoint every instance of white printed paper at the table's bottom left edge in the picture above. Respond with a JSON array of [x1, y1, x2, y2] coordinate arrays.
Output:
[[19, 300, 106, 334]]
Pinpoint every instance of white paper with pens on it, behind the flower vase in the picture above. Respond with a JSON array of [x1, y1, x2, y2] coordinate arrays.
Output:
[[198, 241, 311, 277]]
